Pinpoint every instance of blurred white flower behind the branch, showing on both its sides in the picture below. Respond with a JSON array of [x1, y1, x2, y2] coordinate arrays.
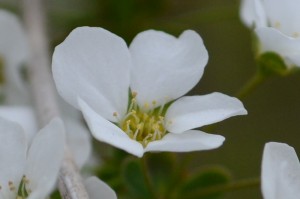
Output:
[[0, 103, 91, 168]]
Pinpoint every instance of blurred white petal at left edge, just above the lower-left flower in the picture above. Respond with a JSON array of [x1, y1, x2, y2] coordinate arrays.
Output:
[[0, 106, 37, 142]]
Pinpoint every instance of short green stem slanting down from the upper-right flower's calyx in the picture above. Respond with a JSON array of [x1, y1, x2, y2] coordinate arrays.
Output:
[[236, 73, 266, 99]]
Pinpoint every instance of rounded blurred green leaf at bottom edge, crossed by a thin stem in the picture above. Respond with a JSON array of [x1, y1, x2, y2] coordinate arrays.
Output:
[[178, 166, 231, 199]]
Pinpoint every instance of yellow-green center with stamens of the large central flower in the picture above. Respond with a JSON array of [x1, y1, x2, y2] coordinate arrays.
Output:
[[118, 92, 166, 147]]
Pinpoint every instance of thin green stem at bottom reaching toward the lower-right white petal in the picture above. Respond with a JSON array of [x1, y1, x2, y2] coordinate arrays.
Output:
[[186, 178, 260, 198]]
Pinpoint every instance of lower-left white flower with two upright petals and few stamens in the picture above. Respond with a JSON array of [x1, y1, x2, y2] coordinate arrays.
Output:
[[0, 118, 65, 199]]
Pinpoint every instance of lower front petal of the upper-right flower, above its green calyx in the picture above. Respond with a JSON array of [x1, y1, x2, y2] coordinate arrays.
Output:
[[255, 28, 300, 66]]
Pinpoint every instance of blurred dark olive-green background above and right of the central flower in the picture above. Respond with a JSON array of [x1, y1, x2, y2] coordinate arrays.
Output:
[[0, 0, 300, 199]]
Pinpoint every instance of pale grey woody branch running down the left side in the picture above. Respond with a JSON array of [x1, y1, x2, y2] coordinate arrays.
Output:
[[22, 0, 88, 199]]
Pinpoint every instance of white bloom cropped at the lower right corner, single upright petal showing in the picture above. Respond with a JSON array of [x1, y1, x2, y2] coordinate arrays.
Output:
[[261, 142, 300, 199]]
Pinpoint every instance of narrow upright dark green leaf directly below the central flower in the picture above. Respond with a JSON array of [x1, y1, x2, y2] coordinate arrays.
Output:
[[122, 159, 151, 199]]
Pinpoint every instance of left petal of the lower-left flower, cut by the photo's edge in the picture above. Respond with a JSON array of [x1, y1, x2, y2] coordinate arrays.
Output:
[[0, 118, 27, 192]]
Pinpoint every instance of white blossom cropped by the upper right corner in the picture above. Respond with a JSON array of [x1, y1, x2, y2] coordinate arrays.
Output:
[[241, 0, 300, 67]]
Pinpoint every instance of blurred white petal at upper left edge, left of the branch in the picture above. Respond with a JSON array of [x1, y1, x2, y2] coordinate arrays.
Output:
[[0, 10, 29, 98]]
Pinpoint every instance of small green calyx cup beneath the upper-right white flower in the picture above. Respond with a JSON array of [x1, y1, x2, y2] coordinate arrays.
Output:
[[257, 52, 289, 76]]
